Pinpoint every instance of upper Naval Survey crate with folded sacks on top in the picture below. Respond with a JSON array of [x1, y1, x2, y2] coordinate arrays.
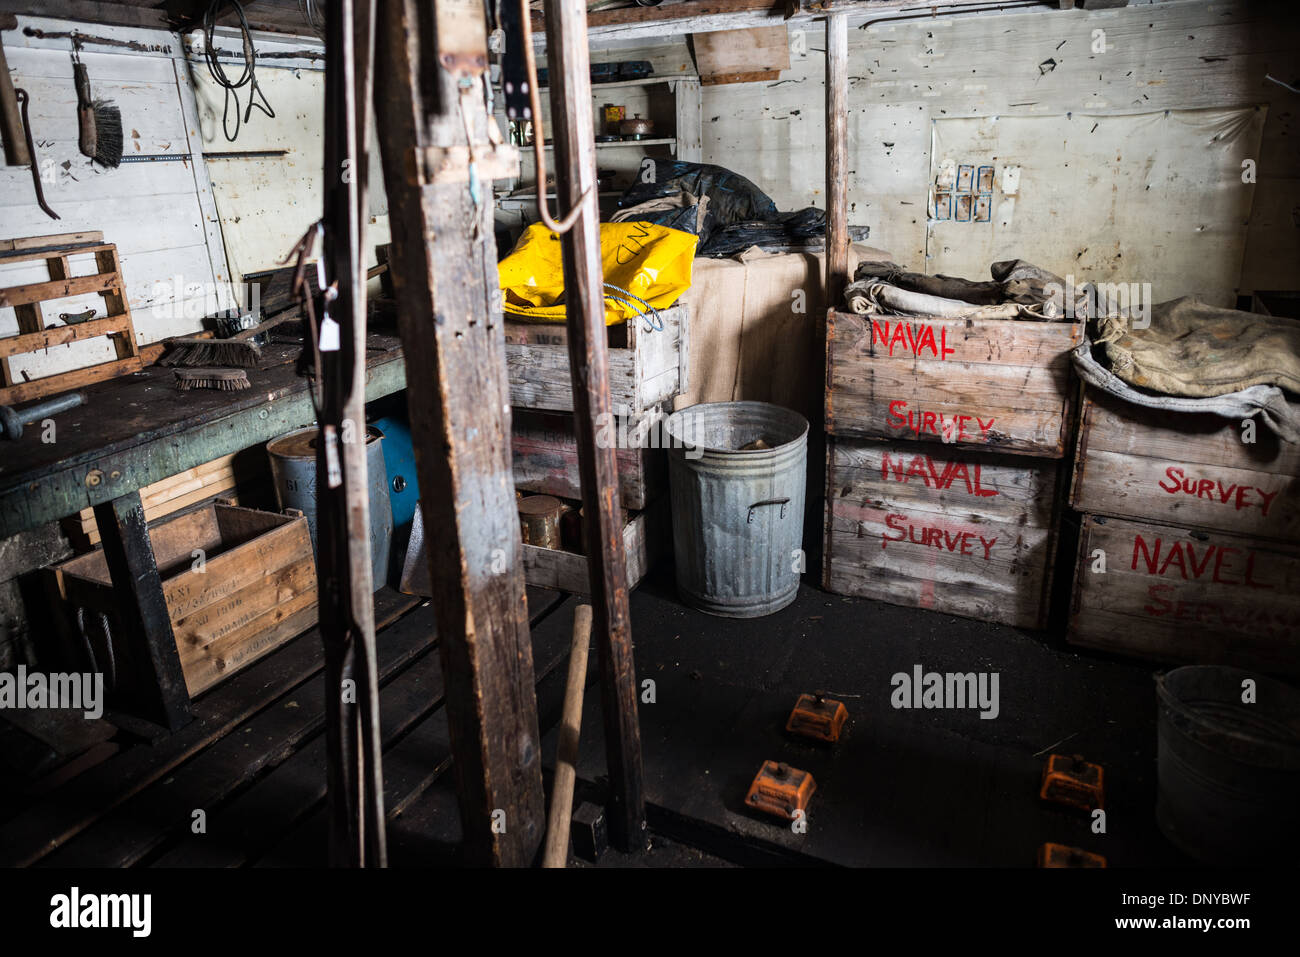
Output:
[[826, 311, 1083, 458]]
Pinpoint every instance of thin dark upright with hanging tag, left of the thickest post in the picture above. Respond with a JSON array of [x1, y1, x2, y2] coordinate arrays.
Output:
[[316, 0, 387, 867]]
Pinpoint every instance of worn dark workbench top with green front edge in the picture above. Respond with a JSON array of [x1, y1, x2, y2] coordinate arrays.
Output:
[[0, 333, 406, 538]]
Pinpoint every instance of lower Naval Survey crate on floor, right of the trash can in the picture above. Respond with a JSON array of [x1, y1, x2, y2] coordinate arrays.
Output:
[[823, 437, 1061, 628]]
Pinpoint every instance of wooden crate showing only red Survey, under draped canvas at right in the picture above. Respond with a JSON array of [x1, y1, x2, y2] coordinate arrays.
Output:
[[1070, 389, 1300, 542]]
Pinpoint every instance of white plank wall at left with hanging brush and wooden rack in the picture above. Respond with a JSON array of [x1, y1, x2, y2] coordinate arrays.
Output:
[[0, 17, 226, 377]]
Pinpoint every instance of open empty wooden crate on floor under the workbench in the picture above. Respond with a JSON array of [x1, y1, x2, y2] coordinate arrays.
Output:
[[55, 505, 316, 696]]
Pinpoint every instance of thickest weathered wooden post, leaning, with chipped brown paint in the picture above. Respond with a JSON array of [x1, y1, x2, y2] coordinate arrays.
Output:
[[376, 0, 545, 866]]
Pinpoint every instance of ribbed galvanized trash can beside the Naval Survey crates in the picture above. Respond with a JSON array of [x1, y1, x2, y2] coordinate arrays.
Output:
[[667, 402, 809, 618]]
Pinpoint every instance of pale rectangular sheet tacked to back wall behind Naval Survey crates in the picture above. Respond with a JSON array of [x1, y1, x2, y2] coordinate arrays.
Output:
[[928, 109, 1264, 306]]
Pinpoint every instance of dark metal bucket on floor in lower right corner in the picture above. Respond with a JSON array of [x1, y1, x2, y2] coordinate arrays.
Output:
[[1156, 666, 1300, 865]]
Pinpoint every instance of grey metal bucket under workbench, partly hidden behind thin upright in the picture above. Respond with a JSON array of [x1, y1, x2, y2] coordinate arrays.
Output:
[[267, 425, 393, 590]]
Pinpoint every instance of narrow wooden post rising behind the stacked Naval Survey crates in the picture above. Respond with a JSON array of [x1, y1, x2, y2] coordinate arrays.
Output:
[[826, 13, 849, 308]]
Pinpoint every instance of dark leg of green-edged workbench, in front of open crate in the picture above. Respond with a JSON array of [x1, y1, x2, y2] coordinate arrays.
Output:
[[95, 492, 191, 731]]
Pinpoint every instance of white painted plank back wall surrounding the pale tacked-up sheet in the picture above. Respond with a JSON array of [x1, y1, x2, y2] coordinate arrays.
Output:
[[676, 0, 1300, 291]]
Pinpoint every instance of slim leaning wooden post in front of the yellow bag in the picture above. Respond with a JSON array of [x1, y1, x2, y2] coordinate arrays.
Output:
[[545, 0, 646, 852]]
